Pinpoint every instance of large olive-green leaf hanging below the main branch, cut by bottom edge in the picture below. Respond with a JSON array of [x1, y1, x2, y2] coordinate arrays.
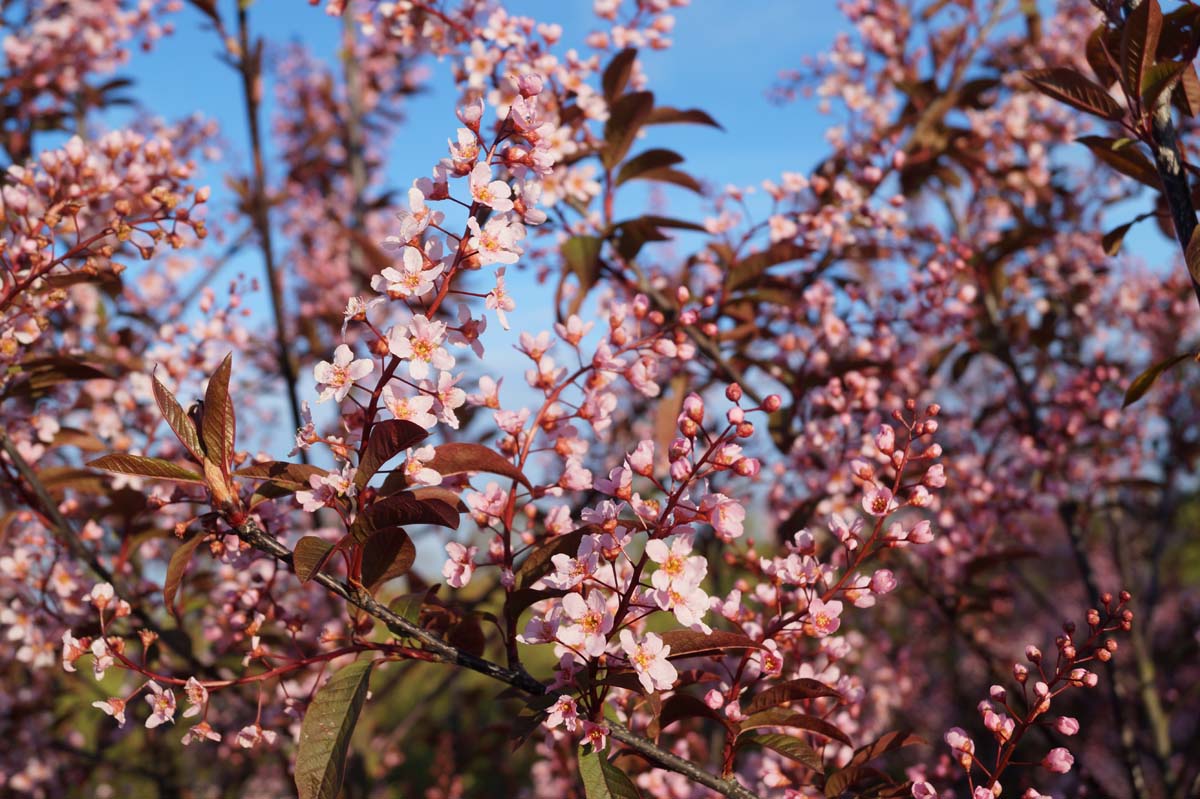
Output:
[[295, 660, 374, 799]]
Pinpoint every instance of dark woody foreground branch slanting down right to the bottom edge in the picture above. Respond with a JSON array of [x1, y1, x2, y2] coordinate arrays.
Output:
[[226, 518, 758, 799]]
